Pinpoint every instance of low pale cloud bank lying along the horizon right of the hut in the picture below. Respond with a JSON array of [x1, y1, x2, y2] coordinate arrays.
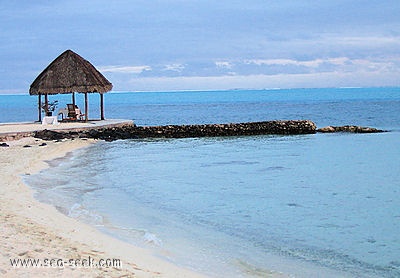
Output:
[[119, 67, 400, 91]]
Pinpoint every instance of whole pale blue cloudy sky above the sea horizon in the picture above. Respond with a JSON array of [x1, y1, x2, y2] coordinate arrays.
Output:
[[0, 0, 400, 94]]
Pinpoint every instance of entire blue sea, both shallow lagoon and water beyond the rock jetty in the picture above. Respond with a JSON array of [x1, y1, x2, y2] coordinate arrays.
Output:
[[6, 88, 400, 277]]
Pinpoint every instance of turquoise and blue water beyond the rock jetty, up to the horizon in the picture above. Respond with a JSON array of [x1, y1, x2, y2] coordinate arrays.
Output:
[[0, 88, 400, 128]]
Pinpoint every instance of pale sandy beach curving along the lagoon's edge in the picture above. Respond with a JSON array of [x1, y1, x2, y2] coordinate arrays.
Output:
[[0, 137, 206, 277]]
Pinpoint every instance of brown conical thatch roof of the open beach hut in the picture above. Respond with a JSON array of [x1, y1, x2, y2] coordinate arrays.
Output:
[[29, 50, 112, 95]]
